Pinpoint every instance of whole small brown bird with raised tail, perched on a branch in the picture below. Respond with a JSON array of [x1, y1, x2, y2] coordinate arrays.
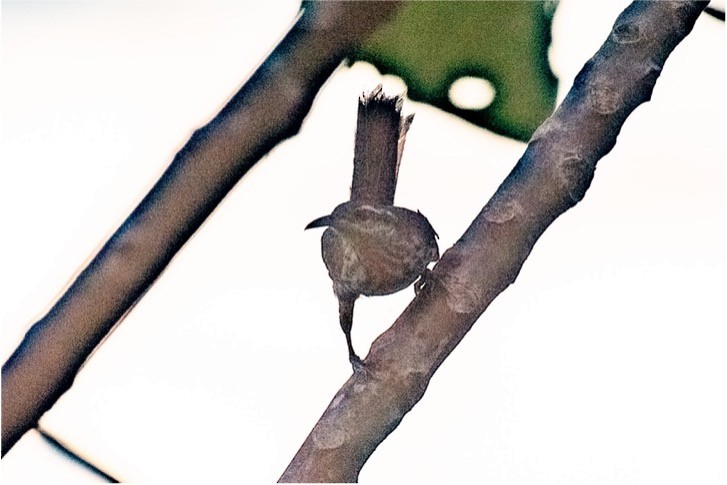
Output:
[[306, 86, 439, 371]]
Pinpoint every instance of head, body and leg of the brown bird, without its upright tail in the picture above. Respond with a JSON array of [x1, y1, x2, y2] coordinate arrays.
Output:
[[306, 202, 439, 371]]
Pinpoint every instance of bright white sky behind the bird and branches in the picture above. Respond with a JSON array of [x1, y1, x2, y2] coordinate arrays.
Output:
[[0, 1, 727, 483]]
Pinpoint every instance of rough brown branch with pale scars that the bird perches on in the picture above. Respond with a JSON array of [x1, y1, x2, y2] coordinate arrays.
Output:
[[280, 1, 707, 482]]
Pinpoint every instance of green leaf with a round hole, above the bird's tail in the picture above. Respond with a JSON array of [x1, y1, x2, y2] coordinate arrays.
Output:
[[352, 1, 557, 140]]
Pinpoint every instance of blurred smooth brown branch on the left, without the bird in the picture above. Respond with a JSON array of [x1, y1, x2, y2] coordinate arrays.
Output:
[[2, 2, 398, 455]]
